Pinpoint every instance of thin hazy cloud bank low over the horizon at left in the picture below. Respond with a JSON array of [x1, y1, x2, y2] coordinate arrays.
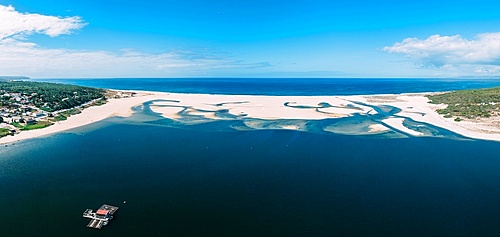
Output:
[[0, 39, 271, 77]]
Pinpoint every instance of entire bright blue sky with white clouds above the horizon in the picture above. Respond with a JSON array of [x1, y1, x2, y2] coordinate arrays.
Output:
[[0, 0, 500, 78]]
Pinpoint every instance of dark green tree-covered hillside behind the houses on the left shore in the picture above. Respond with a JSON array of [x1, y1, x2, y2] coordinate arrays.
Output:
[[0, 81, 106, 112]]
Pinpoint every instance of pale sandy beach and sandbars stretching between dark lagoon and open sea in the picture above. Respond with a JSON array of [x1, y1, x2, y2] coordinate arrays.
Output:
[[0, 90, 500, 144]]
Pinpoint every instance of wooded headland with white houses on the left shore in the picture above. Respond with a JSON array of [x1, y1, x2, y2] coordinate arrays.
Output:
[[0, 80, 134, 137]]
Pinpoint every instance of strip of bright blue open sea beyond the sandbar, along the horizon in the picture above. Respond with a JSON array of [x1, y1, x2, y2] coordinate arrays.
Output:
[[32, 78, 500, 95]]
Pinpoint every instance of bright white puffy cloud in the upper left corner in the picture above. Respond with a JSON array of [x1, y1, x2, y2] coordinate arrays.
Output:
[[0, 5, 85, 41]]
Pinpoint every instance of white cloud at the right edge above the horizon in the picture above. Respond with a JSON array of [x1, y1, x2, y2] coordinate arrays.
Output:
[[384, 32, 500, 74]]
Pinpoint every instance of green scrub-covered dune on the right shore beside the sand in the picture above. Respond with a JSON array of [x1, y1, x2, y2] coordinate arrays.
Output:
[[427, 87, 500, 122]]
